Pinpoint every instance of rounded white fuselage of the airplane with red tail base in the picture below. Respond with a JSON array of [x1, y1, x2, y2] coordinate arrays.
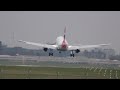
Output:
[[56, 36, 68, 51]]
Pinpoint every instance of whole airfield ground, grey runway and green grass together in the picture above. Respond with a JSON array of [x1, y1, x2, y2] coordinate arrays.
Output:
[[0, 56, 120, 79]]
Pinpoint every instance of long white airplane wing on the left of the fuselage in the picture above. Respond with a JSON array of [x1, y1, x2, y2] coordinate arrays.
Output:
[[19, 40, 57, 49]]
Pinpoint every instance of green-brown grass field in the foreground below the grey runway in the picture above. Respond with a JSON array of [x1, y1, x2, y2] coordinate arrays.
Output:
[[0, 66, 120, 79]]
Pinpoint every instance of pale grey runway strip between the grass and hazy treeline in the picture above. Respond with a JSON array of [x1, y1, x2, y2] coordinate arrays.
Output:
[[0, 55, 120, 69]]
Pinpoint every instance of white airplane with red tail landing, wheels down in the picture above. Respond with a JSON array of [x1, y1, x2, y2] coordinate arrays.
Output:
[[18, 27, 110, 57]]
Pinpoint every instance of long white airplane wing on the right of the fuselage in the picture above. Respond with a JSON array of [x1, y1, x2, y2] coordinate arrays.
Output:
[[68, 44, 110, 50]]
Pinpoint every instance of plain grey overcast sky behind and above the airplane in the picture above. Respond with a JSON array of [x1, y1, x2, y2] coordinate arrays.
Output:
[[0, 11, 120, 51]]
